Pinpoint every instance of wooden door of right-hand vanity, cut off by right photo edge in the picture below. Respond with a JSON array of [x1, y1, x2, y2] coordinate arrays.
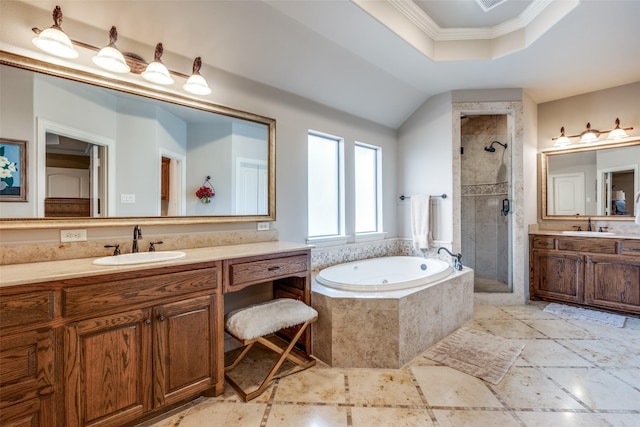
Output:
[[586, 255, 640, 314]]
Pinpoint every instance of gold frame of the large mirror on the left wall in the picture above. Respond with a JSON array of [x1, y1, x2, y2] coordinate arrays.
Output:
[[0, 50, 276, 229]]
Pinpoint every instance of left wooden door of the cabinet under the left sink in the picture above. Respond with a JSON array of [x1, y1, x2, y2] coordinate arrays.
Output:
[[64, 309, 151, 427]]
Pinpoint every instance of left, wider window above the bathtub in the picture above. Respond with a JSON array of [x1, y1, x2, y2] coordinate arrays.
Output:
[[308, 132, 344, 239]]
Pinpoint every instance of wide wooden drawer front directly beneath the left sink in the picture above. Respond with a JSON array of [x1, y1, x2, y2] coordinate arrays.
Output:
[[62, 267, 218, 316]]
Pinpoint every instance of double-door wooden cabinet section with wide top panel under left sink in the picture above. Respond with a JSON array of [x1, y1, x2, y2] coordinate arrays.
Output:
[[63, 265, 224, 427]]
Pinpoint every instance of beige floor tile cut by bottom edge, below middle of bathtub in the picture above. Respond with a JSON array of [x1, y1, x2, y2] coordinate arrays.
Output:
[[351, 407, 434, 427]]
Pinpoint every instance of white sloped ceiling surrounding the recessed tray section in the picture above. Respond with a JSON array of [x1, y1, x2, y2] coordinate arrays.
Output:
[[23, 0, 640, 128]]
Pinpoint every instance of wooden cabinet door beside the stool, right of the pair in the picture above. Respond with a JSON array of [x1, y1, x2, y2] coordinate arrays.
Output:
[[153, 295, 222, 407]]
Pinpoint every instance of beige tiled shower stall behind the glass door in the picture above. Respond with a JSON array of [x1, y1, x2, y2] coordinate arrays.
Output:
[[460, 114, 512, 292]]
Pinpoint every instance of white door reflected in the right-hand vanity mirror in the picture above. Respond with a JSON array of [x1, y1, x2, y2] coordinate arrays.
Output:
[[547, 173, 586, 216]]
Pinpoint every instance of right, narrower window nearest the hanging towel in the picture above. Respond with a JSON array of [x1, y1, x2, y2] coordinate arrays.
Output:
[[354, 143, 382, 233]]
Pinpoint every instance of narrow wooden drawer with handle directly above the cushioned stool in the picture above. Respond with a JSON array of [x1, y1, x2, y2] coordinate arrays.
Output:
[[225, 255, 309, 292]]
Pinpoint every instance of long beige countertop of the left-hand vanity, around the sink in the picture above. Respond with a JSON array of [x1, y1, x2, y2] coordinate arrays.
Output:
[[0, 242, 311, 288]]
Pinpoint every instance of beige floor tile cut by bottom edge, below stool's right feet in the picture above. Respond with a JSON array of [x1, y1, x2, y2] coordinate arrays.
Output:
[[264, 404, 347, 427]]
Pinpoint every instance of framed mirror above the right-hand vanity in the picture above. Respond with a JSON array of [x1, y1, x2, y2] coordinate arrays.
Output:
[[540, 139, 640, 221]]
